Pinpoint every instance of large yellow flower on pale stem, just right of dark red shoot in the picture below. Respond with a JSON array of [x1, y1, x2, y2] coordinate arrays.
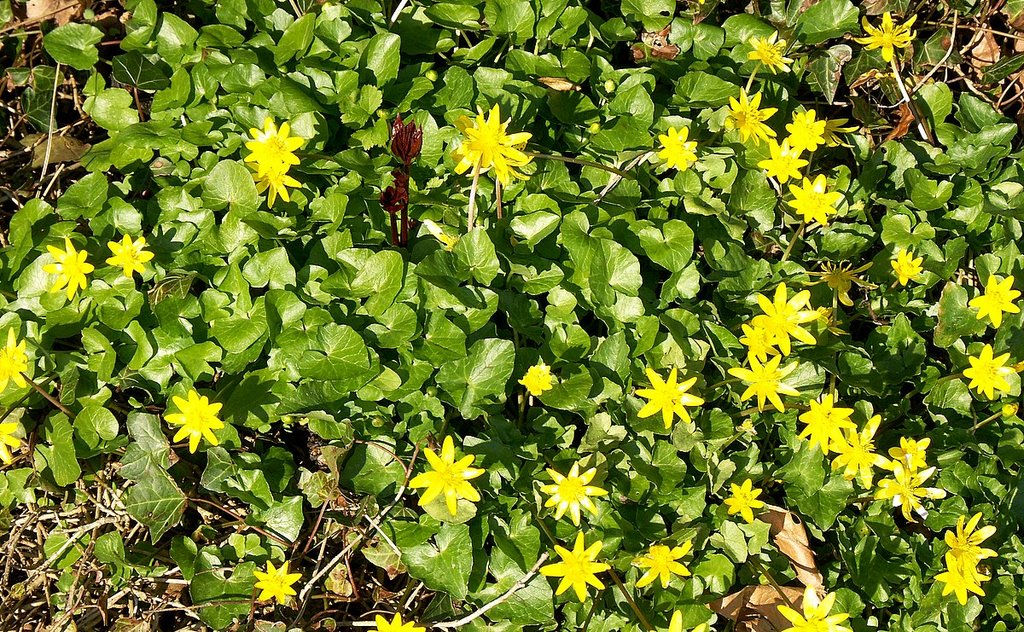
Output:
[[453, 103, 532, 186]]
